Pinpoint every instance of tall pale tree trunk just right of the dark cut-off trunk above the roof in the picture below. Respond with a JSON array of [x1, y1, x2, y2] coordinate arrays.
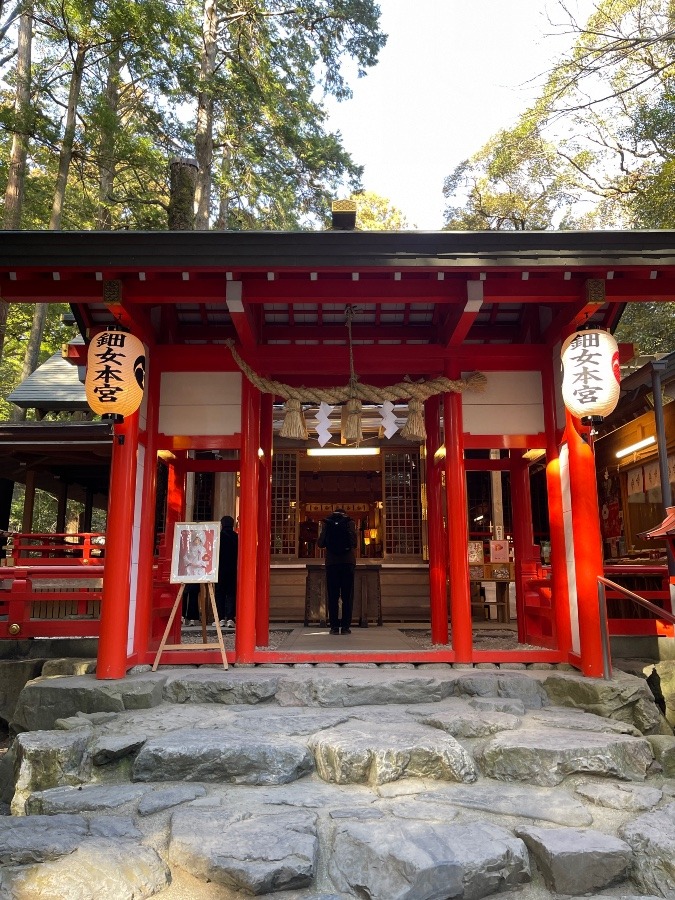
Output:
[[195, 0, 218, 231]]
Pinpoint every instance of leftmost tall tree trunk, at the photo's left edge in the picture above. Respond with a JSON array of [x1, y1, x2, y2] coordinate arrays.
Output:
[[0, 3, 33, 359]]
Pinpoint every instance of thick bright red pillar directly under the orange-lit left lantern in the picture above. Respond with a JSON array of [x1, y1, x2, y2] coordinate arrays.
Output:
[[96, 412, 138, 679]]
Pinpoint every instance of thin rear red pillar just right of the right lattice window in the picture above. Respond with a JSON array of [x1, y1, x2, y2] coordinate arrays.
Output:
[[424, 395, 448, 644]]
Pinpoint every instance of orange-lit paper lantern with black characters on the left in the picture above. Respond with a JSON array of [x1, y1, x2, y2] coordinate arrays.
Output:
[[84, 329, 145, 416]]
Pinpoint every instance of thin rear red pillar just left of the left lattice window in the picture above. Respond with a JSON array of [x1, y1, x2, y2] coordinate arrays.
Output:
[[255, 394, 274, 647]]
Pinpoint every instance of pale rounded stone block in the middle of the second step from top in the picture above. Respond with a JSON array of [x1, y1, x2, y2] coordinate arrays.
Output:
[[309, 724, 478, 785]]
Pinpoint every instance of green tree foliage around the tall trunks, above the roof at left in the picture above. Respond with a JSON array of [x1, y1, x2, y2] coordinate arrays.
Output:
[[0, 0, 386, 229]]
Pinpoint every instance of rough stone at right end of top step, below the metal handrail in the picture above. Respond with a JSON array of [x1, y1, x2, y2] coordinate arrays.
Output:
[[543, 672, 663, 734]]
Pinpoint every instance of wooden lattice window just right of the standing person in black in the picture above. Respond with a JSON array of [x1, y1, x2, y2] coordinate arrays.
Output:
[[384, 450, 422, 556]]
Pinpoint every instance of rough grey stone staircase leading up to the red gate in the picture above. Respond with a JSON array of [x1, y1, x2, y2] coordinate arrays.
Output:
[[0, 664, 675, 900]]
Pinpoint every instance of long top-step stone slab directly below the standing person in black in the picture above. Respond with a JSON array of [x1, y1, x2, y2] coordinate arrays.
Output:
[[277, 670, 452, 707]]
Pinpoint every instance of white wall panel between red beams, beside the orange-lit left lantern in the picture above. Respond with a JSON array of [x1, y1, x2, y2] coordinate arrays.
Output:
[[158, 372, 242, 435]]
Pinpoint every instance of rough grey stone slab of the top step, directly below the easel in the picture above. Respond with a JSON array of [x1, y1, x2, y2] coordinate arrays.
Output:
[[164, 667, 279, 705]]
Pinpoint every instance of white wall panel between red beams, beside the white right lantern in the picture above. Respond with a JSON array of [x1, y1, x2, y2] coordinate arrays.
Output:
[[462, 372, 544, 434]]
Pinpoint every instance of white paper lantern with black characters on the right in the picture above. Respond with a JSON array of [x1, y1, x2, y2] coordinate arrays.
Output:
[[561, 328, 621, 425]]
